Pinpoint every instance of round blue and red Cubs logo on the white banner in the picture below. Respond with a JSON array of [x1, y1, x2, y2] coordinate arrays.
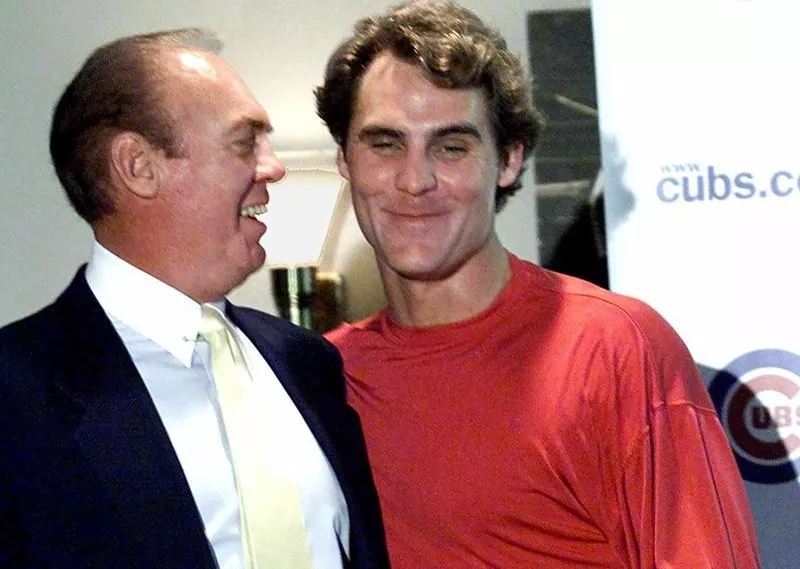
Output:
[[708, 350, 800, 484]]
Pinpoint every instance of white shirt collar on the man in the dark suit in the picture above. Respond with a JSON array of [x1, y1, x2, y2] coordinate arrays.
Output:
[[86, 241, 219, 367]]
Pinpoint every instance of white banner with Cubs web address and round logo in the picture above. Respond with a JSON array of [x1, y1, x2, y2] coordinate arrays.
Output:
[[592, 0, 800, 569]]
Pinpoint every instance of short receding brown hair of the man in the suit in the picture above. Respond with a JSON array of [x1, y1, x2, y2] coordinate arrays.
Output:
[[50, 28, 222, 223]]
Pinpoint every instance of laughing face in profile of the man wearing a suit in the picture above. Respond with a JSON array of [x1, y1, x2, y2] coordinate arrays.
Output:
[[152, 51, 285, 302]]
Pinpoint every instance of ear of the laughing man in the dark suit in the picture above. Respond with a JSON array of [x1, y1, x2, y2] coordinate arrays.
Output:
[[109, 131, 162, 199]]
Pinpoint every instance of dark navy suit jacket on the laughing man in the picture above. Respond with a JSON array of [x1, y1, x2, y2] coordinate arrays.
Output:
[[0, 269, 388, 569]]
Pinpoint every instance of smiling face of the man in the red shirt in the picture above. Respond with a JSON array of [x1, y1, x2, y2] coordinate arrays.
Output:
[[338, 53, 519, 280]]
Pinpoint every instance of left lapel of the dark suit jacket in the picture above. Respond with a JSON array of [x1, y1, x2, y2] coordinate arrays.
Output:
[[55, 270, 214, 567]]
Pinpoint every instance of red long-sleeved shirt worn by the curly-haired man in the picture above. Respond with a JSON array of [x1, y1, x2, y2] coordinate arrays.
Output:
[[328, 256, 759, 569]]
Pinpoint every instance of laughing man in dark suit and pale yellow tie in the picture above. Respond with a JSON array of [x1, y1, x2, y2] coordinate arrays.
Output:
[[0, 30, 387, 569]]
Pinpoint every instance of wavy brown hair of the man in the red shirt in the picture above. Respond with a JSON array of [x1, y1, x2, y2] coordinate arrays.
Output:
[[314, 0, 543, 211]]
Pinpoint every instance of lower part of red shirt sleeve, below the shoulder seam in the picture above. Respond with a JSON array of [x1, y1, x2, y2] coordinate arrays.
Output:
[[622, 404, 759, 569]]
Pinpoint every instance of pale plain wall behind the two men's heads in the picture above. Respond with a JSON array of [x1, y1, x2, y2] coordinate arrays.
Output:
[[0, 0, 588, 324]]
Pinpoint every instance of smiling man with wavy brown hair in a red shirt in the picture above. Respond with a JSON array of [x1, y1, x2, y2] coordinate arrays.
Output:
[[316, 2, 758, 569]]
